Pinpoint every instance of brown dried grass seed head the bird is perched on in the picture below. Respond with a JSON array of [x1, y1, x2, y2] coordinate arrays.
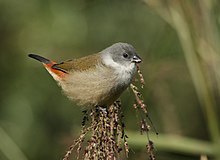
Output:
[[63, 66, 155, 160]]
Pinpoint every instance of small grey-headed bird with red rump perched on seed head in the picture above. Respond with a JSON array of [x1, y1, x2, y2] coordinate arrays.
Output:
[[28, 42, 142, 107]]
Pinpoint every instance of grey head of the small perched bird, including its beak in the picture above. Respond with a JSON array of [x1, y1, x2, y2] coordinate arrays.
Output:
[[101, 42, 141, 66]]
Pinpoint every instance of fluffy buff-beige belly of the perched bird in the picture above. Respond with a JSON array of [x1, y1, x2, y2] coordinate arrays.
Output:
[[60, 65, 132, 106]]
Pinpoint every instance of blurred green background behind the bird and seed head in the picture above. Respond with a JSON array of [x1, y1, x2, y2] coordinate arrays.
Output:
[[0, 0, 220, 160]]
